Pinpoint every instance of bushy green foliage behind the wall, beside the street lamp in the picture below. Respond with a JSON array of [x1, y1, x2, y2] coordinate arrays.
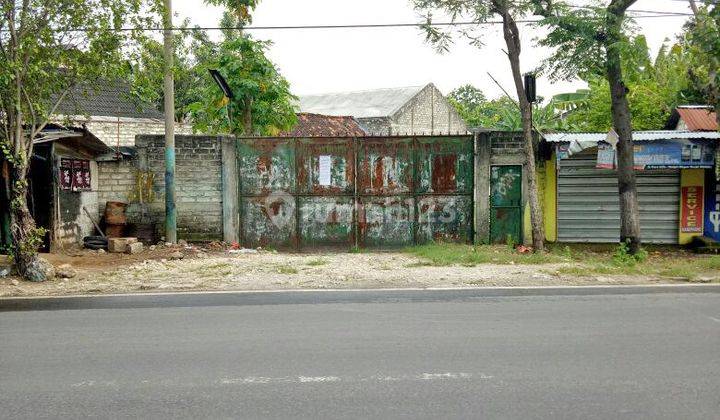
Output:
[[187, 36, 297, 135]]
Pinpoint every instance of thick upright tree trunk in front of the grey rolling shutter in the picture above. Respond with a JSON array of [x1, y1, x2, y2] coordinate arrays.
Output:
[[605, 0, 641, 254]]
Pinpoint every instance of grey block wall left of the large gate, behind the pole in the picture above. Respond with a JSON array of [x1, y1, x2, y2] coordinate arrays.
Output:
[[98, 135, 223, 241]]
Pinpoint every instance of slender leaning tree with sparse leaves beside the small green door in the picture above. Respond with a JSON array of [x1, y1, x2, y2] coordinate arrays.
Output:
[[413, 0, 545, 252]]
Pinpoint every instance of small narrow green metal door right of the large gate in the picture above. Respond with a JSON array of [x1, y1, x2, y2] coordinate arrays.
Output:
[[490, 165, 522, 243]]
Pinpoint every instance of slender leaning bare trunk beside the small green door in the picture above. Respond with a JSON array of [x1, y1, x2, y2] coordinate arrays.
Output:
[[495, 6, 545, 252]]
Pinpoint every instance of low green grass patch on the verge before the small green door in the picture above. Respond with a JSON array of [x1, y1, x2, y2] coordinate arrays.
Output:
[[405, 243, 568, 266]]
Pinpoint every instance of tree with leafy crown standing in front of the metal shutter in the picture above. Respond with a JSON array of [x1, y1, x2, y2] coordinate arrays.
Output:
[[533, 0, 641, 254]]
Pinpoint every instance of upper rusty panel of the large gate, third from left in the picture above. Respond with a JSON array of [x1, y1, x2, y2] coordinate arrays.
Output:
[[358, 138, 414, 196]]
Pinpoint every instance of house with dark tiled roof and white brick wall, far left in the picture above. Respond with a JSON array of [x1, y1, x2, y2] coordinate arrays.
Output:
[[55, 80, 192, 148]]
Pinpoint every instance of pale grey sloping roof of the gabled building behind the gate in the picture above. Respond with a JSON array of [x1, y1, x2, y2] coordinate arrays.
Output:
[[300, 85, 429, 118]]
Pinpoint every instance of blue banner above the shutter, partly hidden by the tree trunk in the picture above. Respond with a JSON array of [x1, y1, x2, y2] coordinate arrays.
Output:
[[597, 140, 715, 170]]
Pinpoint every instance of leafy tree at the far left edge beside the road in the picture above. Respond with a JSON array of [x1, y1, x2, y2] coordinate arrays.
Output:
[[0, 0, 145, 281]]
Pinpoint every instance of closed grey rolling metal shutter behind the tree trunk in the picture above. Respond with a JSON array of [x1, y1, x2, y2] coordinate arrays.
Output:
[[557, 149, 680, 244]]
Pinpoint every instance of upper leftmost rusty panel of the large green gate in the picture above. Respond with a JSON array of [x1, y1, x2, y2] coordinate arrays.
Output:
[[238, 139, 296, 195]]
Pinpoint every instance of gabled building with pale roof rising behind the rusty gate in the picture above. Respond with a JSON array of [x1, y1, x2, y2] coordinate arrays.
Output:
[[300, 83, 467, 135]]
